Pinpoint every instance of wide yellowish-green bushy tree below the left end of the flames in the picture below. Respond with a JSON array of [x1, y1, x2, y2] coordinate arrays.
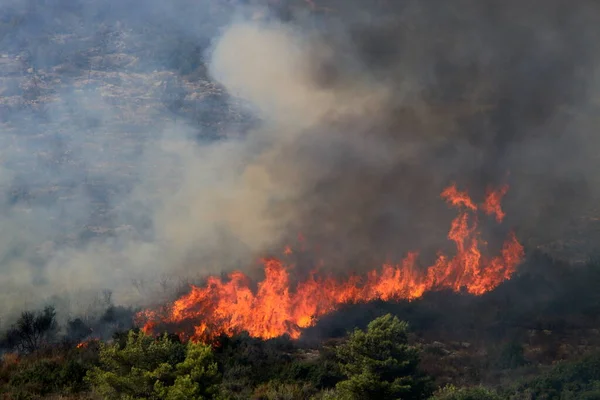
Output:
[[86, 331, 220, 400]]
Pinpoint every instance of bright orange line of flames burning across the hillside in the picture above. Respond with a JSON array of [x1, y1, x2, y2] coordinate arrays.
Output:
[[138, 184, 524, 342]]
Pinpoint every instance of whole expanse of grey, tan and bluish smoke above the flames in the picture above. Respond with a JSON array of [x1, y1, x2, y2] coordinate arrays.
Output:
[[0, 0, 600, 324]]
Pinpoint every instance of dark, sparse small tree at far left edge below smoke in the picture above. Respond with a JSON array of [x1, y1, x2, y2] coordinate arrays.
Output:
[[4, 306, 57, 353]]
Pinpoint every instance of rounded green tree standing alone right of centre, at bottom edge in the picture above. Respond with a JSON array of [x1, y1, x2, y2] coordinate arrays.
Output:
[[336, 314, 429, 400]]
